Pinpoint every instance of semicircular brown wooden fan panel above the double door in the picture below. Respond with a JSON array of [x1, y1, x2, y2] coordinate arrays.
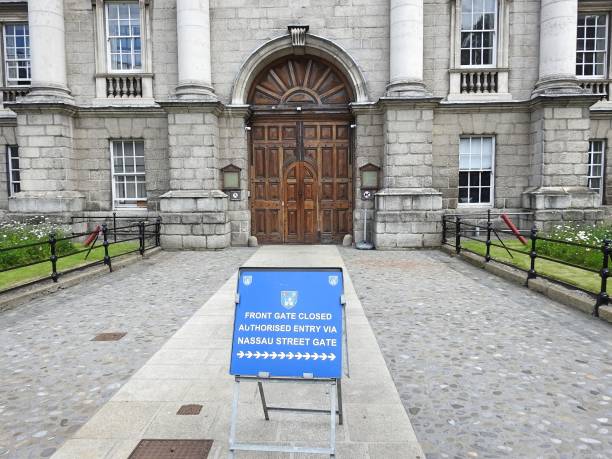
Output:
[[247, 55, 354, 107]]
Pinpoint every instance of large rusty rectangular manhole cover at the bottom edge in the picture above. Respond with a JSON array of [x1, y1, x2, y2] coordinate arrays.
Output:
[[128, 440, 213, 459]]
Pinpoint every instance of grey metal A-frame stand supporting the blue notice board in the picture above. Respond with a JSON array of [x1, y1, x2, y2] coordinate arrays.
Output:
[[229, 268, 349, 459]]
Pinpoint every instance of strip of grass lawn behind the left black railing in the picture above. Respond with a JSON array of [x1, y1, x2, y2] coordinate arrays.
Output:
[[0, 241, 138, 291]]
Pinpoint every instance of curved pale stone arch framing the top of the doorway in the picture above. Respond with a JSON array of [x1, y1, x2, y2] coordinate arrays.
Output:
[[231, 33, 369, 105]]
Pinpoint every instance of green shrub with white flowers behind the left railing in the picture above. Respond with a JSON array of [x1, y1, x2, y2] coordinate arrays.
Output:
[[0, 218, 75, 269]]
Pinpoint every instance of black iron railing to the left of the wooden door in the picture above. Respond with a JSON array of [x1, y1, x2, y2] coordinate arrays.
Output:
[[0, 217, 161, 293]]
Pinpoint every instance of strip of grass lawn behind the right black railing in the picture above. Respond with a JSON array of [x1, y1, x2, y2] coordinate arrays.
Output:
[[461, 239, 612, 293]]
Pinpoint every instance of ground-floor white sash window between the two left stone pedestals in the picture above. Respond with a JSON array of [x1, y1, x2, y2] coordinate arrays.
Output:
[[111, 140, 147, 207]]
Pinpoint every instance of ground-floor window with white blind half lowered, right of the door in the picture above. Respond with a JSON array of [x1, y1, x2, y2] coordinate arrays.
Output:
[[459, 137, 495, 204]]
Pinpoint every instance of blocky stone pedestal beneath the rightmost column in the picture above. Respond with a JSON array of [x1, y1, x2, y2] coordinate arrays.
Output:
[[523, 97, 603, 229]]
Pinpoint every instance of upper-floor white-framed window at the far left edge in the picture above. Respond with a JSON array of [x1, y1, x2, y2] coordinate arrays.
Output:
[[4, 23, 32, 86]]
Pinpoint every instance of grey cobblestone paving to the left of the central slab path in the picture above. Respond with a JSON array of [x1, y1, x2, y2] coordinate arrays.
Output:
[[0, 248, 254, 458]]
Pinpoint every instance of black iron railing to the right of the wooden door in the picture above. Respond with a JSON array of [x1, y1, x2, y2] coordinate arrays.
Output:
[[442, 212, 612, 317]]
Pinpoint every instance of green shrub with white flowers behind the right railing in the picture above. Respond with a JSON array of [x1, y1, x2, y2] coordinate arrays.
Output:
[[537, 224, 612, 269]]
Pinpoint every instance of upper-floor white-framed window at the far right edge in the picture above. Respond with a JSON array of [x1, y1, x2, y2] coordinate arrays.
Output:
[[576, 13, 608, 78]]
